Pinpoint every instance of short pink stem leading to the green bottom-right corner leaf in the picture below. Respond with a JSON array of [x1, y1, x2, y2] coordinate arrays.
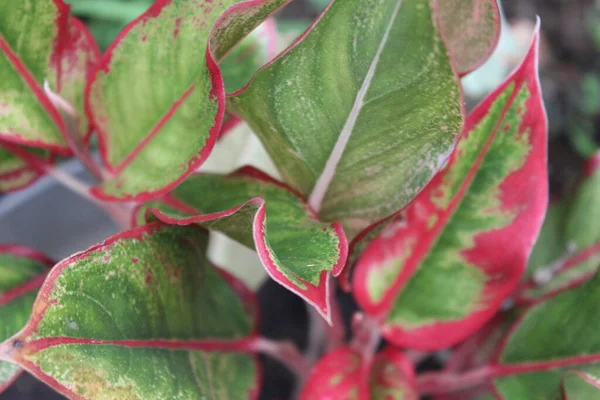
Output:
[[417, 366, 494, 394]]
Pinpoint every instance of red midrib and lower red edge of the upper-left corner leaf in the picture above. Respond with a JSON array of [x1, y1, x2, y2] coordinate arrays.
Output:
[[0, 37, 70, 155]]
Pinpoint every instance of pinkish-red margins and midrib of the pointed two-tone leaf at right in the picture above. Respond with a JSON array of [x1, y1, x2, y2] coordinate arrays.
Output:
[[353, 30, 547, 350]]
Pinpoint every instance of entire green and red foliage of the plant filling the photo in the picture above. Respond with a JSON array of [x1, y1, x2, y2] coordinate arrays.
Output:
[[0, 0, 600, 400]]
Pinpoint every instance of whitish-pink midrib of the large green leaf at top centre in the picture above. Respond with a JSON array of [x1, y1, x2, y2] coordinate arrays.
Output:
[[308, 0, 402, 213]]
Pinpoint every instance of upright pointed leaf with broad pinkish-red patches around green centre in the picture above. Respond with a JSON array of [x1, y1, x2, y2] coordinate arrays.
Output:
[[353, 28, 548, 350]]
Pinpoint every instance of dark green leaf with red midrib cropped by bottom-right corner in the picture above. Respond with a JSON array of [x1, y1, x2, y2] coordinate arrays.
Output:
[[489, 274, 600, 399]]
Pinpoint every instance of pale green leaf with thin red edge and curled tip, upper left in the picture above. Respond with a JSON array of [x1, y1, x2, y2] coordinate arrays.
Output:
[[86, 0, 290, 201]]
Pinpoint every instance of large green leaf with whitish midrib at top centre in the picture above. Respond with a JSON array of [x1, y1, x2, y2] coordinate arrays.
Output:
[[228, 0, 463, 239]]
